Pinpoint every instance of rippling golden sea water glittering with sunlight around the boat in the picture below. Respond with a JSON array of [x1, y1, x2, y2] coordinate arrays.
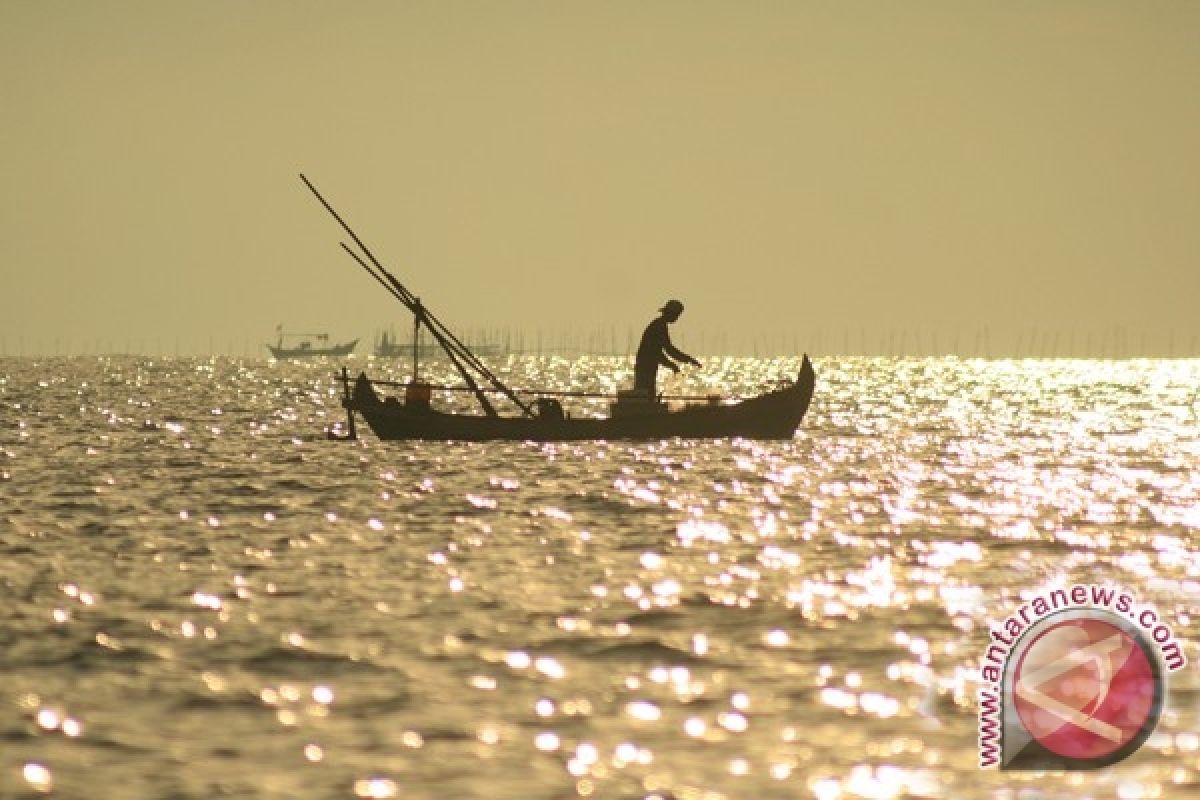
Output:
[[0, 357, 1200, 800]]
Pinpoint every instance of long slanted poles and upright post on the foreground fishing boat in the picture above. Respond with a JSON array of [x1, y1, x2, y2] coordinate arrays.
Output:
[[300, 174, 534, 417]]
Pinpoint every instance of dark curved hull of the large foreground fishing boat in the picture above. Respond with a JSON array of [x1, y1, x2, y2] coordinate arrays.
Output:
[[343, 356, 816, 441]]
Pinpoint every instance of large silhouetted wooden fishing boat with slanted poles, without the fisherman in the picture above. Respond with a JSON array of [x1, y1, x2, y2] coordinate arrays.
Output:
[[300, 175, 816, 441]]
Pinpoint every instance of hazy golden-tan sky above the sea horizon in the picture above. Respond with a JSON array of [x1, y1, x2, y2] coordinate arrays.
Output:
[[0, 0, 1200, 355]]
